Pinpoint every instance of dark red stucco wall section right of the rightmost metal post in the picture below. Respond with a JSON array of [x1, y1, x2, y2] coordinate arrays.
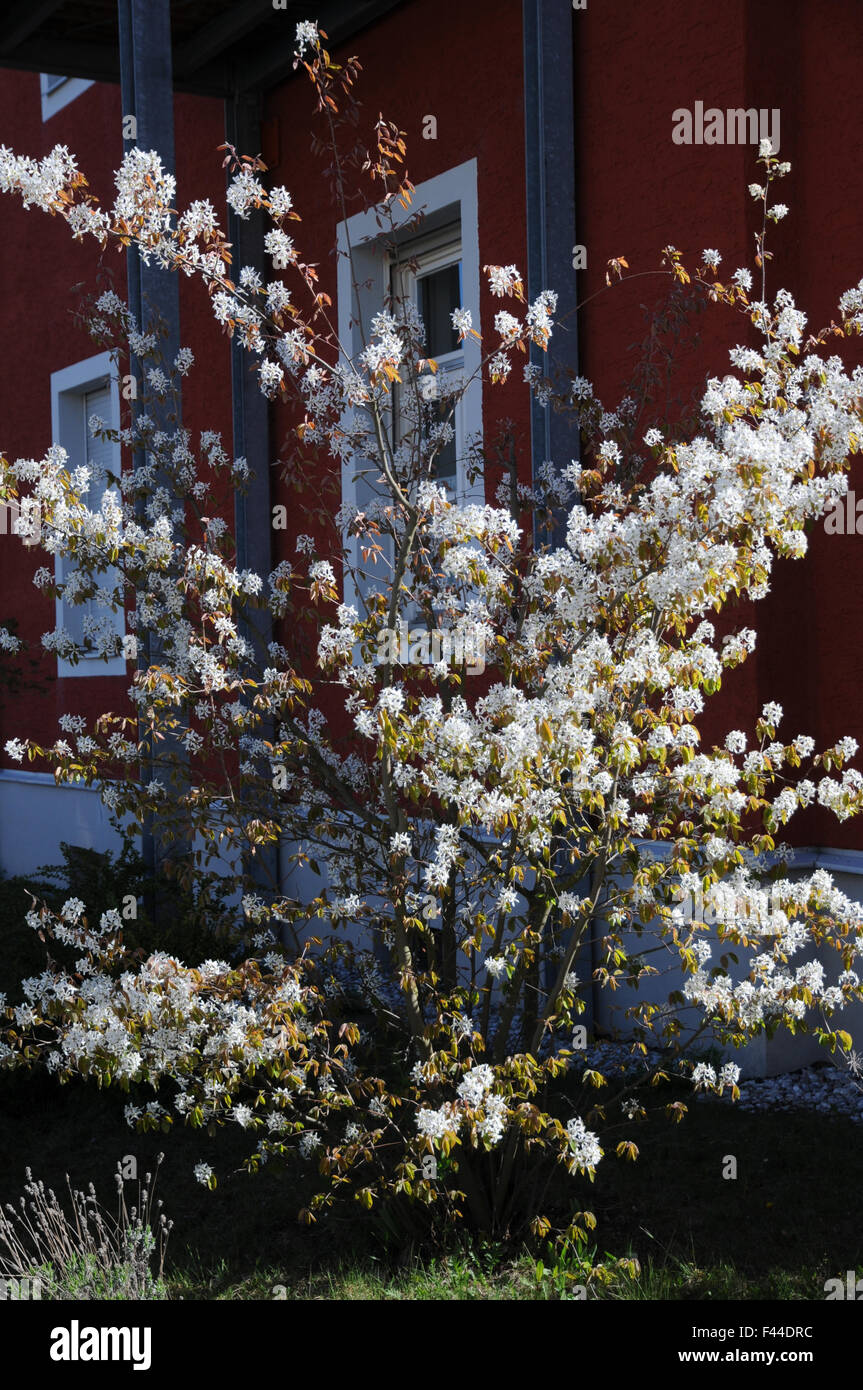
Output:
[[574, 0, 863, 848]]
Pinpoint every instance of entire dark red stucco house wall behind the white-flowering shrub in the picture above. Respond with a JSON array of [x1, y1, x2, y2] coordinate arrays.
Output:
[[0, 0, 863, 847]]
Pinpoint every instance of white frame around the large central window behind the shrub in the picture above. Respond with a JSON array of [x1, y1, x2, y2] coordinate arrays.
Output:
[[336, 158, 485, 606]]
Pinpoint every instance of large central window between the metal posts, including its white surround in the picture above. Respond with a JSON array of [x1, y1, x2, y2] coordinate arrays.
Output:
[[338, 160, 485, 603]]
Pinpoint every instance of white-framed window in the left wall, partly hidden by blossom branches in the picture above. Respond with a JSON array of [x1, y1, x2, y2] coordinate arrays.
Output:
[[51, 352, 128, 677]]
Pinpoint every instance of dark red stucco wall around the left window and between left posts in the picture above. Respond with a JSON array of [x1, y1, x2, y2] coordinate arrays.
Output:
[[0, 71, 231, 765]]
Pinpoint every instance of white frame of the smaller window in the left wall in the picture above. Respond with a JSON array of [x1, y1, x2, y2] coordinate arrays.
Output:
[[51, 352, 128, 678]]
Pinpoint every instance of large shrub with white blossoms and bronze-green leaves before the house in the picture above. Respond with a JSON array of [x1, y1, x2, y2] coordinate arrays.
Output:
[[0, 24, 863, 1236]]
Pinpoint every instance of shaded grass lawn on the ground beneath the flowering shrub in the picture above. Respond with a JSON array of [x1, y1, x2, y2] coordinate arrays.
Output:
[[0, 1076, 863, 1300]]
